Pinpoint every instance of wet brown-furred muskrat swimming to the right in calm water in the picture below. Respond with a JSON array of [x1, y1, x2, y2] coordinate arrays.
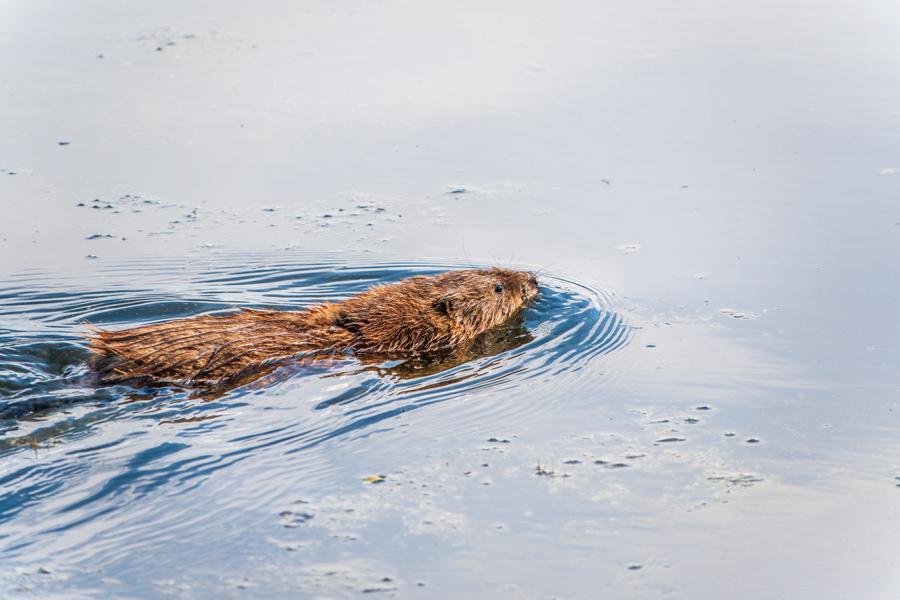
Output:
[[89, 268, 538, 385]]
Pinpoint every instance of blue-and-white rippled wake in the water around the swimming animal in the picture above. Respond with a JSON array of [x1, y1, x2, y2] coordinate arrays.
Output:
[[0, 256, 631, 554]]
